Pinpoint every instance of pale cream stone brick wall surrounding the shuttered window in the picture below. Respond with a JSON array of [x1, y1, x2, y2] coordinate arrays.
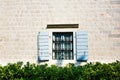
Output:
[[0, 0, 120, 65]]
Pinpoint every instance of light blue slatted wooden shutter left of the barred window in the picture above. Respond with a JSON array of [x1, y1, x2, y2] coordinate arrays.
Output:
[[38, 32, 49, 61]]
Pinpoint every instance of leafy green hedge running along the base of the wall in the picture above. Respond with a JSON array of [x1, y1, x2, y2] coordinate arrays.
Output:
[[0, 61, 120, 80]]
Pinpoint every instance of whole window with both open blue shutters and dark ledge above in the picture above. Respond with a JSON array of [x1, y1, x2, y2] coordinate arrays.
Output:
[[38, 24, 88, 62]]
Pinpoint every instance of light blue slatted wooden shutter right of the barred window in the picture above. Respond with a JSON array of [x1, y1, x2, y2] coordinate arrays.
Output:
[[76, 31, 88, 61]]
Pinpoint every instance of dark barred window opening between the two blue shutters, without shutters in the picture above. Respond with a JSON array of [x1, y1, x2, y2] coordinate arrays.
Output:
[[52, 32, 74, 60]]
